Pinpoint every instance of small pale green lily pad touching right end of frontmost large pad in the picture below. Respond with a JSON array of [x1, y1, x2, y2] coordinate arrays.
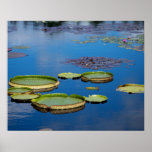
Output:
[[85, 95, 108, 103]]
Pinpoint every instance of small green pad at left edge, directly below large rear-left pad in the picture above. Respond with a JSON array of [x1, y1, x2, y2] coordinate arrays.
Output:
[[8, 87, 32, 95]]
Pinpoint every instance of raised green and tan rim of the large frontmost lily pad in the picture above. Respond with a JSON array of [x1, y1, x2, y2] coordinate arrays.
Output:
[[32, 93, 86, 110]]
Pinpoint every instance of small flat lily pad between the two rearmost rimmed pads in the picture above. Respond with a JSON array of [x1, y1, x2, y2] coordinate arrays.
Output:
[[58, 72, 81, 79]]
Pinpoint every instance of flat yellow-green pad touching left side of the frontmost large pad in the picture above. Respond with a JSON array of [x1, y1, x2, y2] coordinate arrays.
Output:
[[11, 94, 40, 101]]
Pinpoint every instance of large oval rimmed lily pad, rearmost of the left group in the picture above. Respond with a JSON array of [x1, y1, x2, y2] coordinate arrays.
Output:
[[9, 75, 59, 92]]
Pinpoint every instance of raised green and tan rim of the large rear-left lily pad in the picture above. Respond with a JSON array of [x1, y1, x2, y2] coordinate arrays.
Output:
[[9, 75, 59, 92]]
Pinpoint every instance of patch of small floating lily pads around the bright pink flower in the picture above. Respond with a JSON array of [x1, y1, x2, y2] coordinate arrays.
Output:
[[73, 34, 144, 51]]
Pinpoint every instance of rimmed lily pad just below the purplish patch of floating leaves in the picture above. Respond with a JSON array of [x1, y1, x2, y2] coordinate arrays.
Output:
[[81, 71, 113, 83]]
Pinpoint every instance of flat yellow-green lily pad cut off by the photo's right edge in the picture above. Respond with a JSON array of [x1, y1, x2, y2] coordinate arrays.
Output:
[[117, 84, 144, 93]]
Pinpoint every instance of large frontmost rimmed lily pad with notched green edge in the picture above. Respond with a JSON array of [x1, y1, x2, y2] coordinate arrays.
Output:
[[32, 93, 85, 109]]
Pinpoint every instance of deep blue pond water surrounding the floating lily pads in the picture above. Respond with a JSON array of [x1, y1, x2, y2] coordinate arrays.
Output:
[[8, 22, 144, 130]]
